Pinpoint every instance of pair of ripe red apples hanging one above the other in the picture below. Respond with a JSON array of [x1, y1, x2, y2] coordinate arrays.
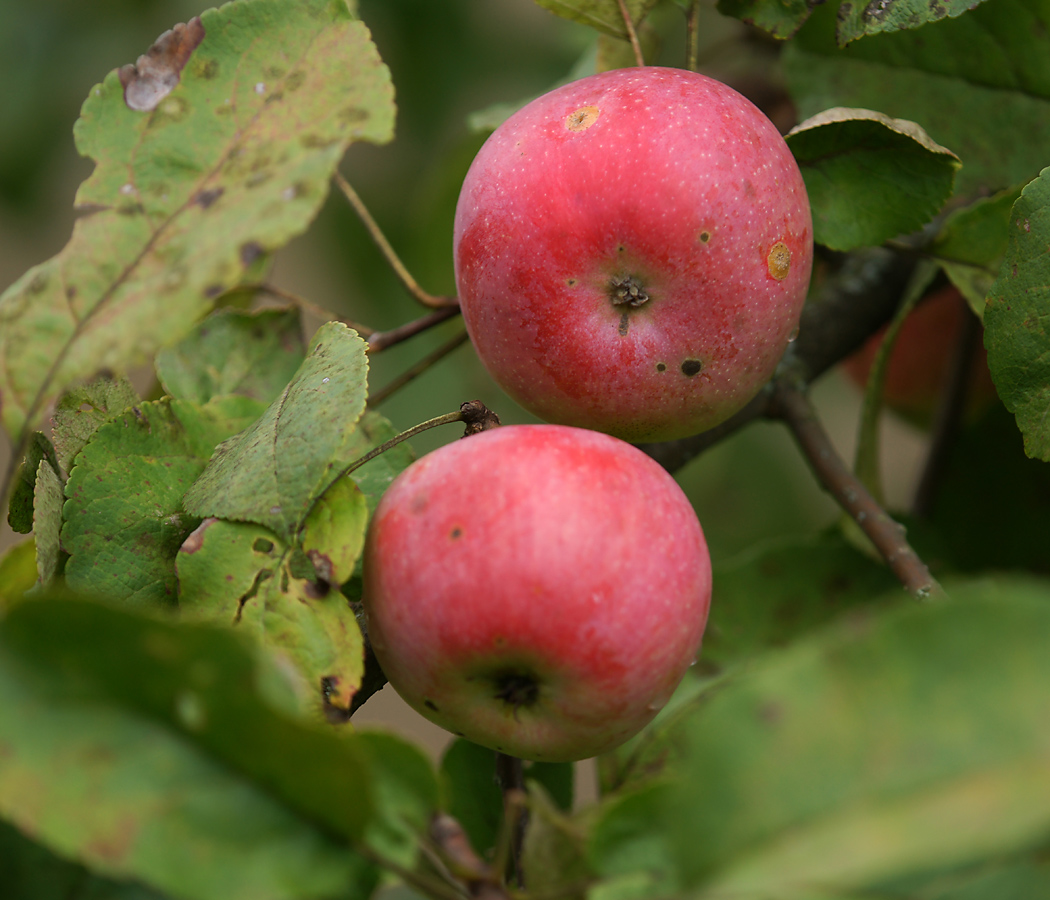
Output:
[[364, 67, 813, 760]]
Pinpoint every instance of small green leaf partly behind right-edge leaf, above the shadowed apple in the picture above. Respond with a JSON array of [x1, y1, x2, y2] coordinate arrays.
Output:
[[931, 187, 1021, 317]]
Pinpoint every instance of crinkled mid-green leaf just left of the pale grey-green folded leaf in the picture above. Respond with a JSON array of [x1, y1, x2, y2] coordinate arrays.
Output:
[[62, 396, 266, 605]]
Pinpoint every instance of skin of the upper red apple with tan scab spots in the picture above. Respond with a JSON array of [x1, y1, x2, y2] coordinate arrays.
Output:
[[454, 67, 813, 441]]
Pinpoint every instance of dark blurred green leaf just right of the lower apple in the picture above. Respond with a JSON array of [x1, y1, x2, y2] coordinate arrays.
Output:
[[700, 530, 898, 669]]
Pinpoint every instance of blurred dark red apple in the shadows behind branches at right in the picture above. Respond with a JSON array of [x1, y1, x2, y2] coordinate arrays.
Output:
[[842, 285, 998, 427]]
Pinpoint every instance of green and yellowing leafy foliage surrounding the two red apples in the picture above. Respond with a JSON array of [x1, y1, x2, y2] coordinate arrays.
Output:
[[0, 0, 1050, 900]]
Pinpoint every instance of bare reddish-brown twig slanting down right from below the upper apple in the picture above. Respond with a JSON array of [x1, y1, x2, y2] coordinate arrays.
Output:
[[770, 379, 944, 600]]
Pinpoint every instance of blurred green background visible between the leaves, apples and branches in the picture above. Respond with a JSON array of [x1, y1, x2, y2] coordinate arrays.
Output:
[[0, 0, 921, 560]]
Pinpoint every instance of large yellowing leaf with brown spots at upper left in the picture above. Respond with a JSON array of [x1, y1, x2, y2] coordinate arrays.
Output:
[[0, 0, 394, 435]]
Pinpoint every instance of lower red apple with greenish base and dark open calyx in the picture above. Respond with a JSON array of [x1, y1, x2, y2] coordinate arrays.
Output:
[[363, 425, 711, 761]]
